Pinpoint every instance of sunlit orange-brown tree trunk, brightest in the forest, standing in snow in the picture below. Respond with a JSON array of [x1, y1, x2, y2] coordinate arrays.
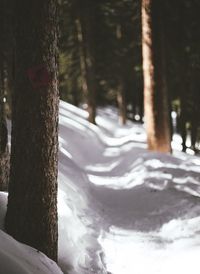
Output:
[[142, 0, 171, 152]]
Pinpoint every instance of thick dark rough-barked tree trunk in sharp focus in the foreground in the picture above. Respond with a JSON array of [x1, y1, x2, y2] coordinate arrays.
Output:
[[6, 0, 59, 261]]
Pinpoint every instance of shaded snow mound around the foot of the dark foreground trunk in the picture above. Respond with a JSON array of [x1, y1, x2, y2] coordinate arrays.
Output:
[[0, 195, 62, 274]]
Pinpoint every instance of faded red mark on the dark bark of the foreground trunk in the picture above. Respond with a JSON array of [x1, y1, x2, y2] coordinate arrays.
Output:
[[27, 65, 51, 88]]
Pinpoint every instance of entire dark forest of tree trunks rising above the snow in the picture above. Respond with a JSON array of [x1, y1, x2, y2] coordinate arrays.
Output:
[[0, 0, 200, 268]]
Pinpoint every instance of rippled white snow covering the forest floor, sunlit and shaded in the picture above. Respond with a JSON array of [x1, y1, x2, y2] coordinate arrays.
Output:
[[0, 101, 200, 274]]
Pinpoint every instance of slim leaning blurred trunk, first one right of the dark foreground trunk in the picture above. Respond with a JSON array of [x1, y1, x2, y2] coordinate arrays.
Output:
[[76, 0, 96, 124]]
